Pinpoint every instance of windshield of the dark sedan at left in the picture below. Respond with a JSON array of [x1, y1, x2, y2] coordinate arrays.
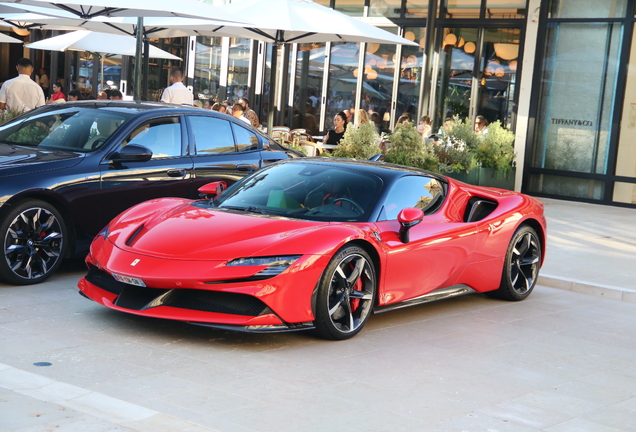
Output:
[[0, 107, 132, 152]]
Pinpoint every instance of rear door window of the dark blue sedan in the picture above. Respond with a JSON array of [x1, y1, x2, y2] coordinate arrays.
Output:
[[189, 116, 236, 155]]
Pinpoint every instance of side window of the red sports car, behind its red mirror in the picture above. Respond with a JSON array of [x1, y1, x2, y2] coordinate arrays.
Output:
[[379, 176, 444, 220]]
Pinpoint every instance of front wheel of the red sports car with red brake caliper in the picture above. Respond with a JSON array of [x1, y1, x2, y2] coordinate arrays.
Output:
[[314, 246, 377, 340]]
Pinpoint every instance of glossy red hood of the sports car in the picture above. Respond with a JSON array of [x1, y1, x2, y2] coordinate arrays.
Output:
[[109, 202, 329, 261]]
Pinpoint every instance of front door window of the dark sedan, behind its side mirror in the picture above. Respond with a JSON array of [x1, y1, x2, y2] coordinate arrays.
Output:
[[124, 117, 181, 159]]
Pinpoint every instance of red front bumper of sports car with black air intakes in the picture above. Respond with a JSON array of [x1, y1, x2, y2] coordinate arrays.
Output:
[[79, 242, 329, 332]]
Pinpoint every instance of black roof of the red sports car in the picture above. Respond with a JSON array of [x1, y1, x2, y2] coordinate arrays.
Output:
[[278, 157, 448, 183]]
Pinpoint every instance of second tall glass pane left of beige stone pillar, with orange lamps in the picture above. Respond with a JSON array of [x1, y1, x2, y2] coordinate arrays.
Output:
[[434, 28, 479, 125]]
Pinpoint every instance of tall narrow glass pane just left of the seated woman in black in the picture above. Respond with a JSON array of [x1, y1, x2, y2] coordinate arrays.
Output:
[[291, 43, 325, 135]]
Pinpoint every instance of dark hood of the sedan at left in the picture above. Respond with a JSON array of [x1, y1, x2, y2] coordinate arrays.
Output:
[[0, 144, 83, 176]]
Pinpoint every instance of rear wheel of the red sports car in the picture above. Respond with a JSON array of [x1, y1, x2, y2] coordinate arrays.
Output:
[[487, 225, 543, 301]]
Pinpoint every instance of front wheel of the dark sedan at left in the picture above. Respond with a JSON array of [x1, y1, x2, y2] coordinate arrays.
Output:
[[0, 200, 68, 285]]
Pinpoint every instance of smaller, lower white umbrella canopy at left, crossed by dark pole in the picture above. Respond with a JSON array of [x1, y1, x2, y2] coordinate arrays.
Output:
[[25, 30, 181, 60]]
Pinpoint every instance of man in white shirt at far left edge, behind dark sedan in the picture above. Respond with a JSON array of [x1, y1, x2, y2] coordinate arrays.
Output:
[[0, 58, 44, 112]]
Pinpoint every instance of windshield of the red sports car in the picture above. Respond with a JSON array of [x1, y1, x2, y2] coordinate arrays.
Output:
[[214, 163, 382, 222]]
